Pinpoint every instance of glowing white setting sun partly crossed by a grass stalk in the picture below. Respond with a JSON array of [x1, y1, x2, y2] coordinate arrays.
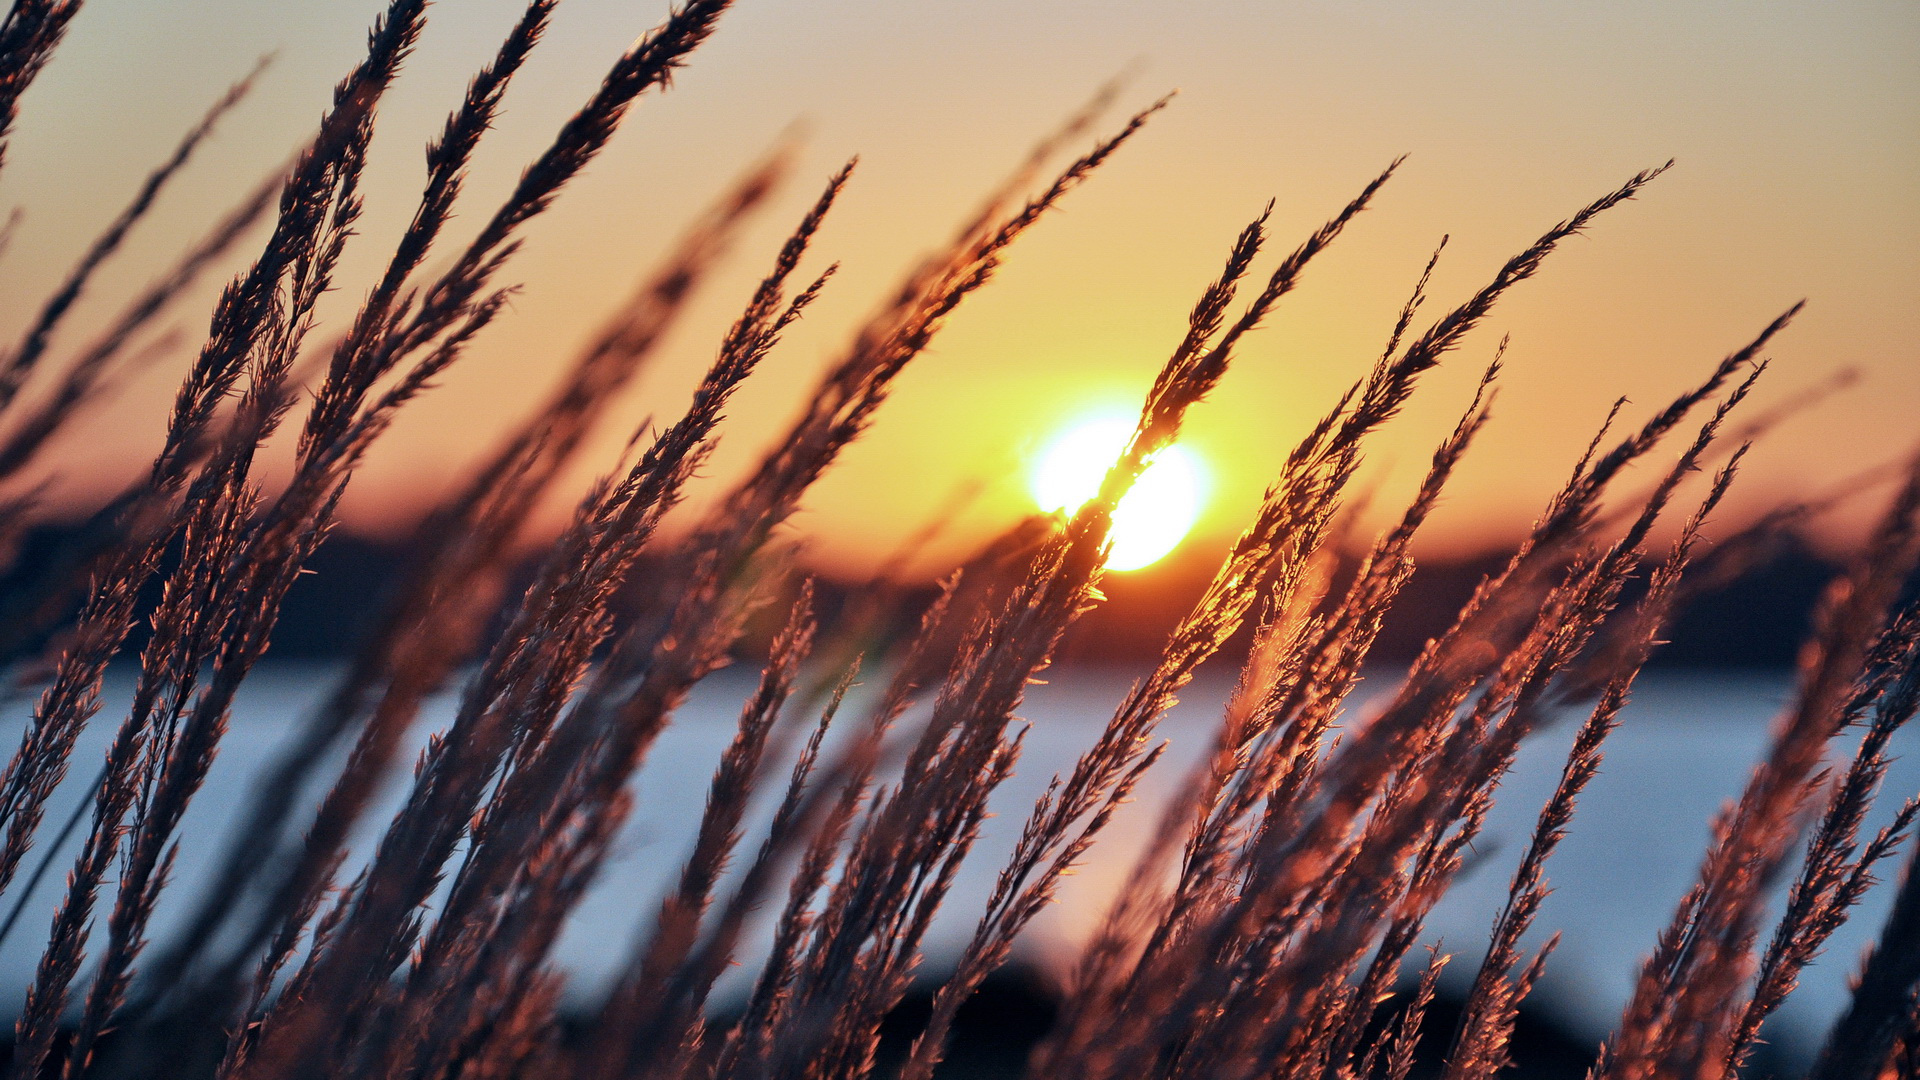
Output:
[[1027, 417, 1202, 571]]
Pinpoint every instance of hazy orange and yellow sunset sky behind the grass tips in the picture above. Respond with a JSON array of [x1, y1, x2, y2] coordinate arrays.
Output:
[[0, 0, 1920, 565]]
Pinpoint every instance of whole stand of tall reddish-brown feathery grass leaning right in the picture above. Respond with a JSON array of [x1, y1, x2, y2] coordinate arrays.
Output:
[[0, 0, 1920, 1080]]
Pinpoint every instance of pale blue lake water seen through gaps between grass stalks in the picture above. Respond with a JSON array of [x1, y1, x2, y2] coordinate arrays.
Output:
[[0, 663, 1920, 1057]]
